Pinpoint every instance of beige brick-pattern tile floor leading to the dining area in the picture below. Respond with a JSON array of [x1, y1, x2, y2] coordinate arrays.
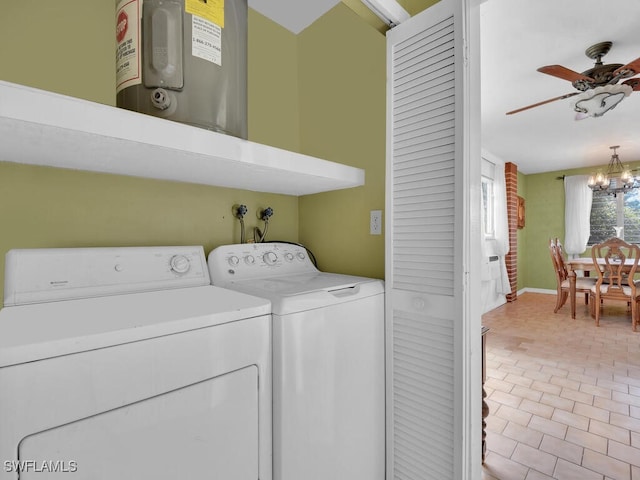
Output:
[[482, 293, 640, 480]]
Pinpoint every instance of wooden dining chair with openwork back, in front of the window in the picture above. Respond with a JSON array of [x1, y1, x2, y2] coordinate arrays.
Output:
[[591, 237, 640, 332]]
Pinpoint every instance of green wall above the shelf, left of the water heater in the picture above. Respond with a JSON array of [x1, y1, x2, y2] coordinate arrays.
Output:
[[0, 0, 115, 106]]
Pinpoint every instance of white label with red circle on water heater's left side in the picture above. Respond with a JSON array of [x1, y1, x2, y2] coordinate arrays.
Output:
[[116, 0, 142, 92]]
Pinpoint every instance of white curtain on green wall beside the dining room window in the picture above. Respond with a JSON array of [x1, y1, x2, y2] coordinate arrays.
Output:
[[564, 175, 593, 255]]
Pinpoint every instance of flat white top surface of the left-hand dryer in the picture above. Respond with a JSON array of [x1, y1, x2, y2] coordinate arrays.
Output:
[[0, 285, 271, 367]]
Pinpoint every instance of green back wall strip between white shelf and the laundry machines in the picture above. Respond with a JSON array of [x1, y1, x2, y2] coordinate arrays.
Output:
[[0, 162, 297, 251]]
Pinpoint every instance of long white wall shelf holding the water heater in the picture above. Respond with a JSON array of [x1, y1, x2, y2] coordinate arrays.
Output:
[[0, 81, 364, 195]]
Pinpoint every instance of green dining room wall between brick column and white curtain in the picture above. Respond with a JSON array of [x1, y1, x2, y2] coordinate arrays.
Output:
[[518, 162, 639, 290]]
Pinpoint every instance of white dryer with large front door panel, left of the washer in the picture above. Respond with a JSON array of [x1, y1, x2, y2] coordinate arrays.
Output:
[[0, 247, 272, 480]]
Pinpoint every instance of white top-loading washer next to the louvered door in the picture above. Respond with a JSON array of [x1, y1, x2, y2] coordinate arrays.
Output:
[[208, 243, 385, 480]]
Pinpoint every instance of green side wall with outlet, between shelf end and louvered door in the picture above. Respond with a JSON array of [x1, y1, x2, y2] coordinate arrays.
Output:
[[299, 4, 386, 278]]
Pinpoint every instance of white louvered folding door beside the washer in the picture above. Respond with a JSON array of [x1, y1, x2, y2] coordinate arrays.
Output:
[[386, 0, 481, 480]]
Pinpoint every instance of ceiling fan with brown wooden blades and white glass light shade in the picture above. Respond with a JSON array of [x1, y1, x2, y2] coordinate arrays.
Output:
[[507, 42, 640, 116]]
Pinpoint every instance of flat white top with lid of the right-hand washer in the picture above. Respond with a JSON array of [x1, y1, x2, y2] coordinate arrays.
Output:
[[221, 271, 384, 315]]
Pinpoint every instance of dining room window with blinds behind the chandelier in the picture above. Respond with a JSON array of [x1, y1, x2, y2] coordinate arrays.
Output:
[[589, 189, 640, 245]]
